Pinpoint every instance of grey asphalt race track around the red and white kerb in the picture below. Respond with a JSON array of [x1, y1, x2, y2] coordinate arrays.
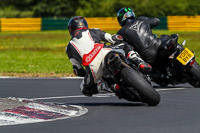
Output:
[[0, 78, 200, 133]]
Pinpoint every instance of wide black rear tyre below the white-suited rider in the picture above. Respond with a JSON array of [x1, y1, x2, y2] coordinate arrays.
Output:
[[121, 68, 160, 106]]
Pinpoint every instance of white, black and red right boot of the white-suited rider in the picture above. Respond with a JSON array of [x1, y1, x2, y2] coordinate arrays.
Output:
[[127, 51, 152, 74]]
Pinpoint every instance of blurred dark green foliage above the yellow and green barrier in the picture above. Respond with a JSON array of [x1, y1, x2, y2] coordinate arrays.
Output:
[[0, 0, 200, 18]]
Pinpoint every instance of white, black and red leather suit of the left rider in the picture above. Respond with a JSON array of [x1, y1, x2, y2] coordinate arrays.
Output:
[[66, 29, 132, 96]]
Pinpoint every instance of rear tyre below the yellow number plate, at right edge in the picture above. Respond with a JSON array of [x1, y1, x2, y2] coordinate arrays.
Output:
[[188, 61, 200, 87]]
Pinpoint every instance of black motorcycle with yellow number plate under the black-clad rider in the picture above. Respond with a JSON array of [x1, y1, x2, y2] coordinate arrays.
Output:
[[151, 35, 200, 87]]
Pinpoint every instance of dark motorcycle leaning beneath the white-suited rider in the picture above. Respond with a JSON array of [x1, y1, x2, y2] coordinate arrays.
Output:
[[103, 52, 160, 106]]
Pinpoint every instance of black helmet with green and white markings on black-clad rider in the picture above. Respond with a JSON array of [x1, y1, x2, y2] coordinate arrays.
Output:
[[117, 8, 135, 26]]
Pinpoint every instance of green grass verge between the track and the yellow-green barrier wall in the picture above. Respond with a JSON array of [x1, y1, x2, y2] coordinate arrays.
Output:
[[0, 30, 200, 76]]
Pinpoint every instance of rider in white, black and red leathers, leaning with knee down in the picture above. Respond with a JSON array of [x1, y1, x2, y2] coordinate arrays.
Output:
[[66, 16, 150, 96]]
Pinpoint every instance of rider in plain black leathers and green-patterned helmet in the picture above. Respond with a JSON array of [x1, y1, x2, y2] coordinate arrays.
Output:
[[117, 8, 174, 65]]
